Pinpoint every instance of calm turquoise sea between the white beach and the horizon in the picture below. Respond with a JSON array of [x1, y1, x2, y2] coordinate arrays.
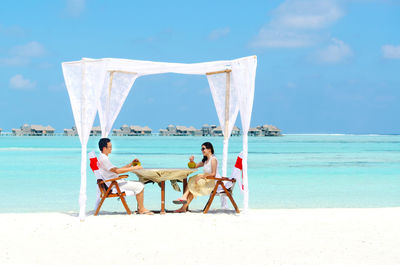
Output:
[[0, 135, 400, 213]]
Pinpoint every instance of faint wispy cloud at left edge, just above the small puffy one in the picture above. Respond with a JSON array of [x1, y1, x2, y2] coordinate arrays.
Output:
[[0, 41, 46, 66]]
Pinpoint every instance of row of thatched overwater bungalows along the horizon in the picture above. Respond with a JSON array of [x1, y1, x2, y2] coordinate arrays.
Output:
[[0, 124, 282, 136]]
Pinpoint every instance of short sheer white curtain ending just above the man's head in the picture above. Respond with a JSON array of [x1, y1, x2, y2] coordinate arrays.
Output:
[[98, 71, 138, 137]]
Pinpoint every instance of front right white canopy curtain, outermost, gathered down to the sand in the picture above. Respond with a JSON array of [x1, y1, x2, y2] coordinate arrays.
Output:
[[232, 56, 257, 211]]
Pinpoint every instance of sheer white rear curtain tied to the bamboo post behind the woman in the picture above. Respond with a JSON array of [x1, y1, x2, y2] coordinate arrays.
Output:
[[207, 72, 239, 177]]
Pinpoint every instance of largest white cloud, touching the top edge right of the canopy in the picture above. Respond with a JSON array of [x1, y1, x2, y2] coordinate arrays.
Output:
[[250, 0, 344, 48]]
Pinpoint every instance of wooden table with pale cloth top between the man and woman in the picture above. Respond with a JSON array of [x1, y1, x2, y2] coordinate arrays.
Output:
[[132, 168, 197, 214]]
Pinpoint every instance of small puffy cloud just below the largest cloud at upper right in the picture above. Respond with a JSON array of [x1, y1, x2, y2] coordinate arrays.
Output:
[[316, 39, 353, 64]]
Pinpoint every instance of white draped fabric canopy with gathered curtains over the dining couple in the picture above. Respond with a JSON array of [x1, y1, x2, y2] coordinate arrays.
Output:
[[62, 56, 257, 220]]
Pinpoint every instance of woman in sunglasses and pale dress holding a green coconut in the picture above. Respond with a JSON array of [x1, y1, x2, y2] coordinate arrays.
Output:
[[173, 142, 220, 213]]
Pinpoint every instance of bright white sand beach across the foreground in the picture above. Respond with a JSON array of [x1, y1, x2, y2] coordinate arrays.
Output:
[[0, 208, 400, 265]]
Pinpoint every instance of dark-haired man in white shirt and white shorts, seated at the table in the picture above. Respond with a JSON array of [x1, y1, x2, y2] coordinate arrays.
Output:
[[98, 138, 153, 215]]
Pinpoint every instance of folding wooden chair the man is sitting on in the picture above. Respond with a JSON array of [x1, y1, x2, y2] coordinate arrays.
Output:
[[94, 175, 132, 216]]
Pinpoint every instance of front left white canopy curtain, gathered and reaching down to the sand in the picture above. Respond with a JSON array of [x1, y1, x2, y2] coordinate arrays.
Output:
[[62, 61, 105, 220]]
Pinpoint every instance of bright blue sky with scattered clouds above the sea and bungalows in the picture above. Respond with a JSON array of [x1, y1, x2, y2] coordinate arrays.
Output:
[[0, 0, 400, 134]]
